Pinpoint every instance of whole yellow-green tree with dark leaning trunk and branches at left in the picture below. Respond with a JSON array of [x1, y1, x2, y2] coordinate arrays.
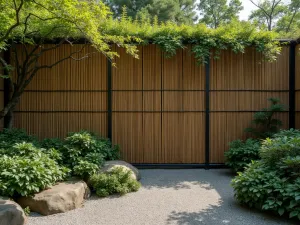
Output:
[[0, 0, 136, 127]]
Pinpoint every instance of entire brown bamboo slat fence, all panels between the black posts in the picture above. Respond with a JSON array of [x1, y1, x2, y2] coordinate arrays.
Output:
[[8, 45, 292, 163]]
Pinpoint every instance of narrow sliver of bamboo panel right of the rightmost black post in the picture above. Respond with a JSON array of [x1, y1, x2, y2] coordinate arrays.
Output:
[[295, 44, 300, 129]]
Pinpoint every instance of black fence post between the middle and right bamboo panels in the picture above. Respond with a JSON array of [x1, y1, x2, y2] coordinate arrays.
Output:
[[205, 58, 210, 169]]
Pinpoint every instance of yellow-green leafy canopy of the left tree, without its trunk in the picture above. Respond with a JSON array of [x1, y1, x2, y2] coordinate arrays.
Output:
[[0, 0, 136, 58]]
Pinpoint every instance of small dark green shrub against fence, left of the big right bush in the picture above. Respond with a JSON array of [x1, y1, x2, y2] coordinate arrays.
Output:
[[225, 139, 261, 172]]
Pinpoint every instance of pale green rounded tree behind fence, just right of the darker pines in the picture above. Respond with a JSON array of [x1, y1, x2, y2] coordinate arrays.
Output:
[[198, 0, 243, 28]]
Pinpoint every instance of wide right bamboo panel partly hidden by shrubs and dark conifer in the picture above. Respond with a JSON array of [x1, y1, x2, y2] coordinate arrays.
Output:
[[210, 47, 289, 163]]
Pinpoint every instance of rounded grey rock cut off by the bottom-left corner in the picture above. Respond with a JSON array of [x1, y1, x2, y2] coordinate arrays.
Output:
[[0, 197, 27, 225]]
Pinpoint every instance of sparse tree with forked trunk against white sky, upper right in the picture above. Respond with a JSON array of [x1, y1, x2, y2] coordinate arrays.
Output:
[[249, 0, 288, 31]]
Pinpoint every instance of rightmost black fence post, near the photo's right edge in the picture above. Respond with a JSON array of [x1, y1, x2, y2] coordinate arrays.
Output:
[[289, 43, 296, 128]]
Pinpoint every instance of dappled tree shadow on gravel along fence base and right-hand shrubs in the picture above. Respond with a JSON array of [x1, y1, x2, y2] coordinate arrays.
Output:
[[142, 169, 299, 225]]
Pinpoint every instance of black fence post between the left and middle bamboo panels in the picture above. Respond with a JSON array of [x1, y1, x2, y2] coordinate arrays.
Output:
[[107, 59, 112, 140]]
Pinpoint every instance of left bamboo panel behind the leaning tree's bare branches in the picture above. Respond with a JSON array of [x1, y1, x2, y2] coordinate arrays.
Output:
[[14, 45, 107, 138]]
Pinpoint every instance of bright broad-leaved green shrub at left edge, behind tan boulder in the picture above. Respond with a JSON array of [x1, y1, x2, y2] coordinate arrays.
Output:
[[0, 143, 68, 197]]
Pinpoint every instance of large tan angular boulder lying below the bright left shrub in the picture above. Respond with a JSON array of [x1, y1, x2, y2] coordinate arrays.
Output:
[[18, 181, 90, 216]]
